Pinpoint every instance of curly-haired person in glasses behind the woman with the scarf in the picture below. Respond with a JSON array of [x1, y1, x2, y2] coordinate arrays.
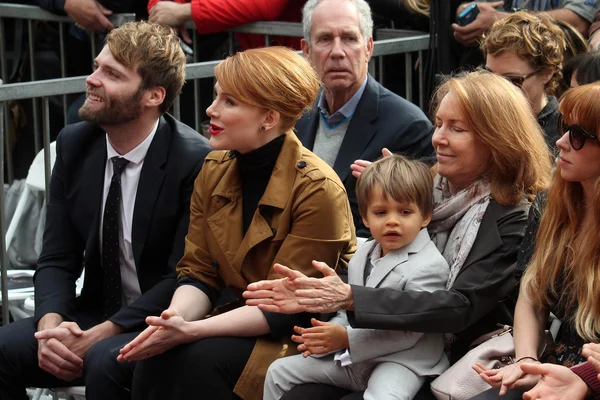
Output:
[[481, 11, 566, 150]]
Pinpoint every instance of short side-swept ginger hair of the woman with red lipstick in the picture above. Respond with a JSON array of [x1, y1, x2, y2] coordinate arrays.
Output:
[[215, 46, 319, 130]]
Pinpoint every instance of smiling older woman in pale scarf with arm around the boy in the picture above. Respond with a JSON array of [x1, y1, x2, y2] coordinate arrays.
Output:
[[244, 71, 550, 399]]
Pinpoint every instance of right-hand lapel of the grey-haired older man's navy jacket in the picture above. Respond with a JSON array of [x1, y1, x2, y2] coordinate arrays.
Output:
[[330, 76, 379, 182]]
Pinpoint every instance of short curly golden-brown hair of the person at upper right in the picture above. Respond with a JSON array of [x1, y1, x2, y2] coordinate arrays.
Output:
[[481, 11, 566, 93]]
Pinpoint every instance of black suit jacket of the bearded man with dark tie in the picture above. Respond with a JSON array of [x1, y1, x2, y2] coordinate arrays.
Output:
[[35, 114, 211, 331]]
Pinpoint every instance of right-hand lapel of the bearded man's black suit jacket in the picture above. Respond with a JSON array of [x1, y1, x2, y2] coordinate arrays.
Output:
[[131, 117, 172, 269]]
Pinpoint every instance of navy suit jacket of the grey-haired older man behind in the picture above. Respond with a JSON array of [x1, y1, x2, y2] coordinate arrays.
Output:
[[296, 76, 433, 237]]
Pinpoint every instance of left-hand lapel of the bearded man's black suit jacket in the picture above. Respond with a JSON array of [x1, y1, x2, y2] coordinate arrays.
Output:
[[81, 128, 106, 259]]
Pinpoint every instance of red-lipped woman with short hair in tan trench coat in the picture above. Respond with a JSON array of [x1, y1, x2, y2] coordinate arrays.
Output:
[[119, 47, 356, 400]]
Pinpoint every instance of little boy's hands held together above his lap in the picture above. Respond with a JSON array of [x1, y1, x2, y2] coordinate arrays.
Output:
[[292, 318, 350, 357]]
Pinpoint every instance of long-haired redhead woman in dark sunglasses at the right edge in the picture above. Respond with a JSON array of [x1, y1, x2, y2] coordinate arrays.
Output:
[[474, 83, 600, 400]]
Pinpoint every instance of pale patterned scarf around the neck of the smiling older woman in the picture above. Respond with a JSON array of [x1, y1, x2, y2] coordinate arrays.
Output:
[[428, 175, 491, 289]]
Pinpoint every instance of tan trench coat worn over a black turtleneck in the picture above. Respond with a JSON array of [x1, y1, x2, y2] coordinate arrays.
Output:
[[177, 132, 356, 400]]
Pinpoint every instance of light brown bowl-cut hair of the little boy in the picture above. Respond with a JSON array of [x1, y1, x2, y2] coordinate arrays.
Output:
[[356, 154, 433, 217]]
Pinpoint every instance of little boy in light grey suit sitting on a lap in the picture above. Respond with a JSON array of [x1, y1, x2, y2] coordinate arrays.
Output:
[[264, 155, 449, 400]]
